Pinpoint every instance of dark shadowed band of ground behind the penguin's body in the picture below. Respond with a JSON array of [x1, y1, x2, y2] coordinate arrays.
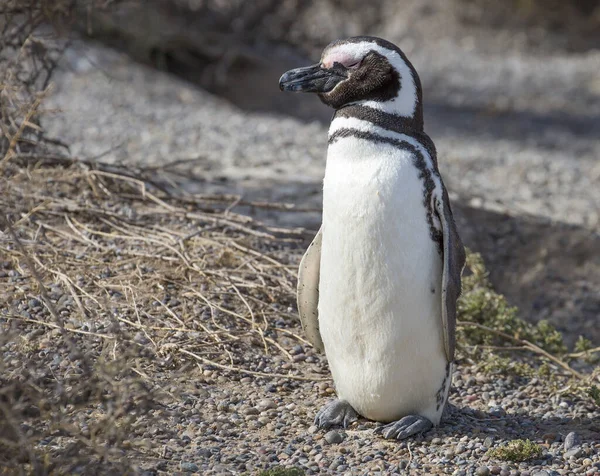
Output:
[[155, 165, 600, 346]]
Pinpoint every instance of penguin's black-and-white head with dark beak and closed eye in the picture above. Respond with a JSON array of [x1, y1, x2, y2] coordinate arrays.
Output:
[[279, 36, 421, 117]]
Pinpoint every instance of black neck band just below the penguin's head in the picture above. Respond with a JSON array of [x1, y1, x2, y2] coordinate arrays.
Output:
[[333, 100, 423, 134]]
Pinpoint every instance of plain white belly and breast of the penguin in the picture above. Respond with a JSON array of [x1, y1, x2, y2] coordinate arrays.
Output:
[[319, 138, 447, 424]]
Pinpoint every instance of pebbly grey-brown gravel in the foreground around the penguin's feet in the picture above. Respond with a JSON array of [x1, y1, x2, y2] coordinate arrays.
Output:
[[140, 362, 600, 476]]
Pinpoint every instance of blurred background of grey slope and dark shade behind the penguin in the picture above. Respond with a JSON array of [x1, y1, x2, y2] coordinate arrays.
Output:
[[0, 0, 600, 344]]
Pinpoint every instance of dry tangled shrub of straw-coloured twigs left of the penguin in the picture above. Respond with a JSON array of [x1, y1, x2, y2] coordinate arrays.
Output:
[[0, 158, 312, 474]]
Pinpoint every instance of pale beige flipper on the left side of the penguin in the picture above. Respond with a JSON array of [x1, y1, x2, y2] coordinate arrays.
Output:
[[297, 227, 325, 352]]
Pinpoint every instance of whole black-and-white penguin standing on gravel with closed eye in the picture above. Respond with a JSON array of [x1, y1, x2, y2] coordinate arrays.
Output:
[[279, 37, 465, 439]]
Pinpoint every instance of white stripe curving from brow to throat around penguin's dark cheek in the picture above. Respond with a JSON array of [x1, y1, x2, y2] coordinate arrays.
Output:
[[321, 41, 417, 117]]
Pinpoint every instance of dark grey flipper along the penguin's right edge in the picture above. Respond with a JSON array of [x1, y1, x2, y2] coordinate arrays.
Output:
[[435, 188, 466, 362]]
